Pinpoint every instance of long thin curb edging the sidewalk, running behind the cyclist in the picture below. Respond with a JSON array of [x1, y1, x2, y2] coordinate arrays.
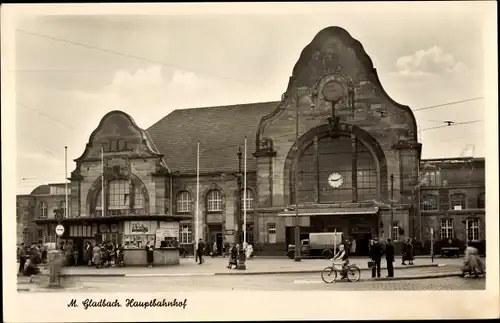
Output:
[[50, 264, 440, 277]]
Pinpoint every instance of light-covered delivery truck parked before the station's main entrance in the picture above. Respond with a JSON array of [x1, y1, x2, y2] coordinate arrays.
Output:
[[287, 232, 343, 259]]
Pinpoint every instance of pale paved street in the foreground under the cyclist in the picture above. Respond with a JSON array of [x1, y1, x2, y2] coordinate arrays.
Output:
[[18, 266, 485, 293]]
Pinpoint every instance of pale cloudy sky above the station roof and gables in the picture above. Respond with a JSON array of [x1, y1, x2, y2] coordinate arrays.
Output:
[[7, 2, 494, 194]]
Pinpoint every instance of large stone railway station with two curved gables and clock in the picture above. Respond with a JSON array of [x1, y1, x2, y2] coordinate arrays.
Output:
[[18, 27, 485, 255]]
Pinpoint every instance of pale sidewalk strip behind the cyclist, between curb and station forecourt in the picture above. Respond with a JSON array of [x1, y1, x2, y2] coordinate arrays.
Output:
[[33, 258, 461, 277]]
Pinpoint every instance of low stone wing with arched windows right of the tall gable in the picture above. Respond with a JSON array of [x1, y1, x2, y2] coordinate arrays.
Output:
[[420, 158, 486, 253]]
